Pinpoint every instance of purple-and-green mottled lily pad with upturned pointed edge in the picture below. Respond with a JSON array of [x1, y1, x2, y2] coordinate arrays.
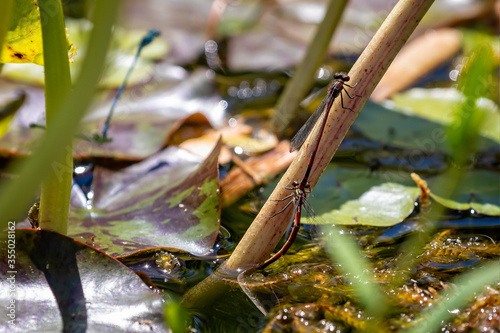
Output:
[[68, 140, 220, 256]]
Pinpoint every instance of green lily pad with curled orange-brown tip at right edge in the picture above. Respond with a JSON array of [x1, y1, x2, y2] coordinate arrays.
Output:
[[428, 171, 500, 216]]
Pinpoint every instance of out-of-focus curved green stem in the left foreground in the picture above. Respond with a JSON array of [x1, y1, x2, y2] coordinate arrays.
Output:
[[0, 0, 121, 224]]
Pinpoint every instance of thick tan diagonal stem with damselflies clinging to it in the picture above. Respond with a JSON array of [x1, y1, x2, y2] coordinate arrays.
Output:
[[226, 0, 433, 271]]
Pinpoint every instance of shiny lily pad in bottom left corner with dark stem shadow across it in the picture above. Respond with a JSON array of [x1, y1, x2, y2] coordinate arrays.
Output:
[[0, 229, 167, 332]]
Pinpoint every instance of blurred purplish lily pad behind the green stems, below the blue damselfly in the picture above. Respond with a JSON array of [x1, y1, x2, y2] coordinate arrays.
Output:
[[0, 68, 227, 160]]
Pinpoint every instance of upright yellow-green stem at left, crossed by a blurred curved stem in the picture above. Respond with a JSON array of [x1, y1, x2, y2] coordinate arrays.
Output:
[[38, 0, 73, 234]]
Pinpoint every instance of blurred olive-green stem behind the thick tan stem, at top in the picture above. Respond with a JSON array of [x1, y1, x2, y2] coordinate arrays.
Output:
[[273, 0, 347, 131]]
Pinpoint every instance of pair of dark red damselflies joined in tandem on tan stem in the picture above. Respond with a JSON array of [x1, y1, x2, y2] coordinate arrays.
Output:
[[261, 73, 360, 268]]
